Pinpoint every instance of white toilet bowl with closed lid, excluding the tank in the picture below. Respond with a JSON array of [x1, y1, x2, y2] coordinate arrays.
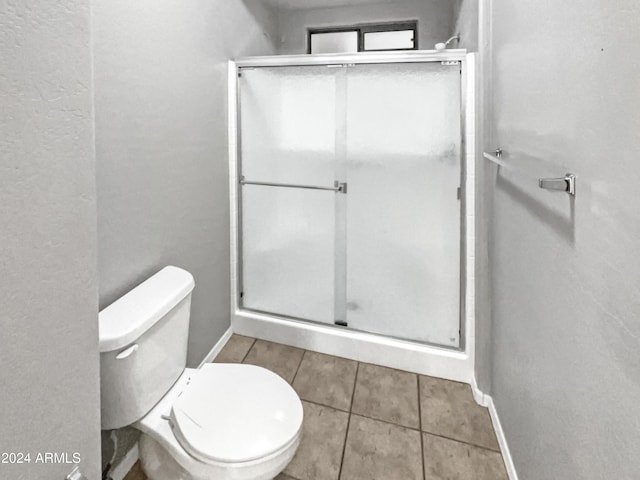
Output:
[[133, 364, 302, 480]]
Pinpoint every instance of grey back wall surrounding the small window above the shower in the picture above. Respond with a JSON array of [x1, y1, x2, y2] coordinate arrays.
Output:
[[278, 0, 454, 55]]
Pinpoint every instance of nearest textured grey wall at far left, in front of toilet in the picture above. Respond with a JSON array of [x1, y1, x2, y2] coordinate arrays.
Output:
[[0, 0, 100, 480]]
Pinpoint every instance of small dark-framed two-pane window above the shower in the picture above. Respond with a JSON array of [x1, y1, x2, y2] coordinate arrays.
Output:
[[307, 20, 418, 53]]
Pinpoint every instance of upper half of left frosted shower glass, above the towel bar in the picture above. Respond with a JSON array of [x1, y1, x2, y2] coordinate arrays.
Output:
[[240, 67, 336, 185]]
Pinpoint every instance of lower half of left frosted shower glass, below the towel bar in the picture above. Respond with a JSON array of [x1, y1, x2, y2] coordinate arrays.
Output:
[[242, 185, 335, 324]]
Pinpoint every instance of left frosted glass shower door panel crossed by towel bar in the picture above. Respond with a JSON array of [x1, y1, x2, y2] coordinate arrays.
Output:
[[239, 67, 336, 324]]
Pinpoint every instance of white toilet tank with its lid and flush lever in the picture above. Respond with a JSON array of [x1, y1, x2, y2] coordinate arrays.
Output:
[[99, 266, 195, 430]]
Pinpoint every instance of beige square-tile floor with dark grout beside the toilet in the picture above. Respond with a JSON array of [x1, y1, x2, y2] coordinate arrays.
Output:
[[125, 335, 508, 480]]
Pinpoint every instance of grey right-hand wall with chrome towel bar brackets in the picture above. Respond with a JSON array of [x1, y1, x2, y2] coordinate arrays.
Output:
[[485, 0, 640, 480]]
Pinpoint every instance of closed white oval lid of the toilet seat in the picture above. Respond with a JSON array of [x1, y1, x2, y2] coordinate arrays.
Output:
[[171, 364, 302, 463]]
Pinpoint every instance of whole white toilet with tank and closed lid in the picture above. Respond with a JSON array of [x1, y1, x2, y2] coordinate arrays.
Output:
[[99, 266, 303, 480]]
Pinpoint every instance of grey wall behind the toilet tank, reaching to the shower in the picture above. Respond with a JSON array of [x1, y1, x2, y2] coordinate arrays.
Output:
[[93, 0, 276, 472]]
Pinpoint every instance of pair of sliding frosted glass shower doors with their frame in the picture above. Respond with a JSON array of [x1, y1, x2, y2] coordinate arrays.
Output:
[[230, 51, 466, 364]]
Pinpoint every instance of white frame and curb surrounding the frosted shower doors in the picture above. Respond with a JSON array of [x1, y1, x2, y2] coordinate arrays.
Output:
[[228, 49, 475, 383]]
